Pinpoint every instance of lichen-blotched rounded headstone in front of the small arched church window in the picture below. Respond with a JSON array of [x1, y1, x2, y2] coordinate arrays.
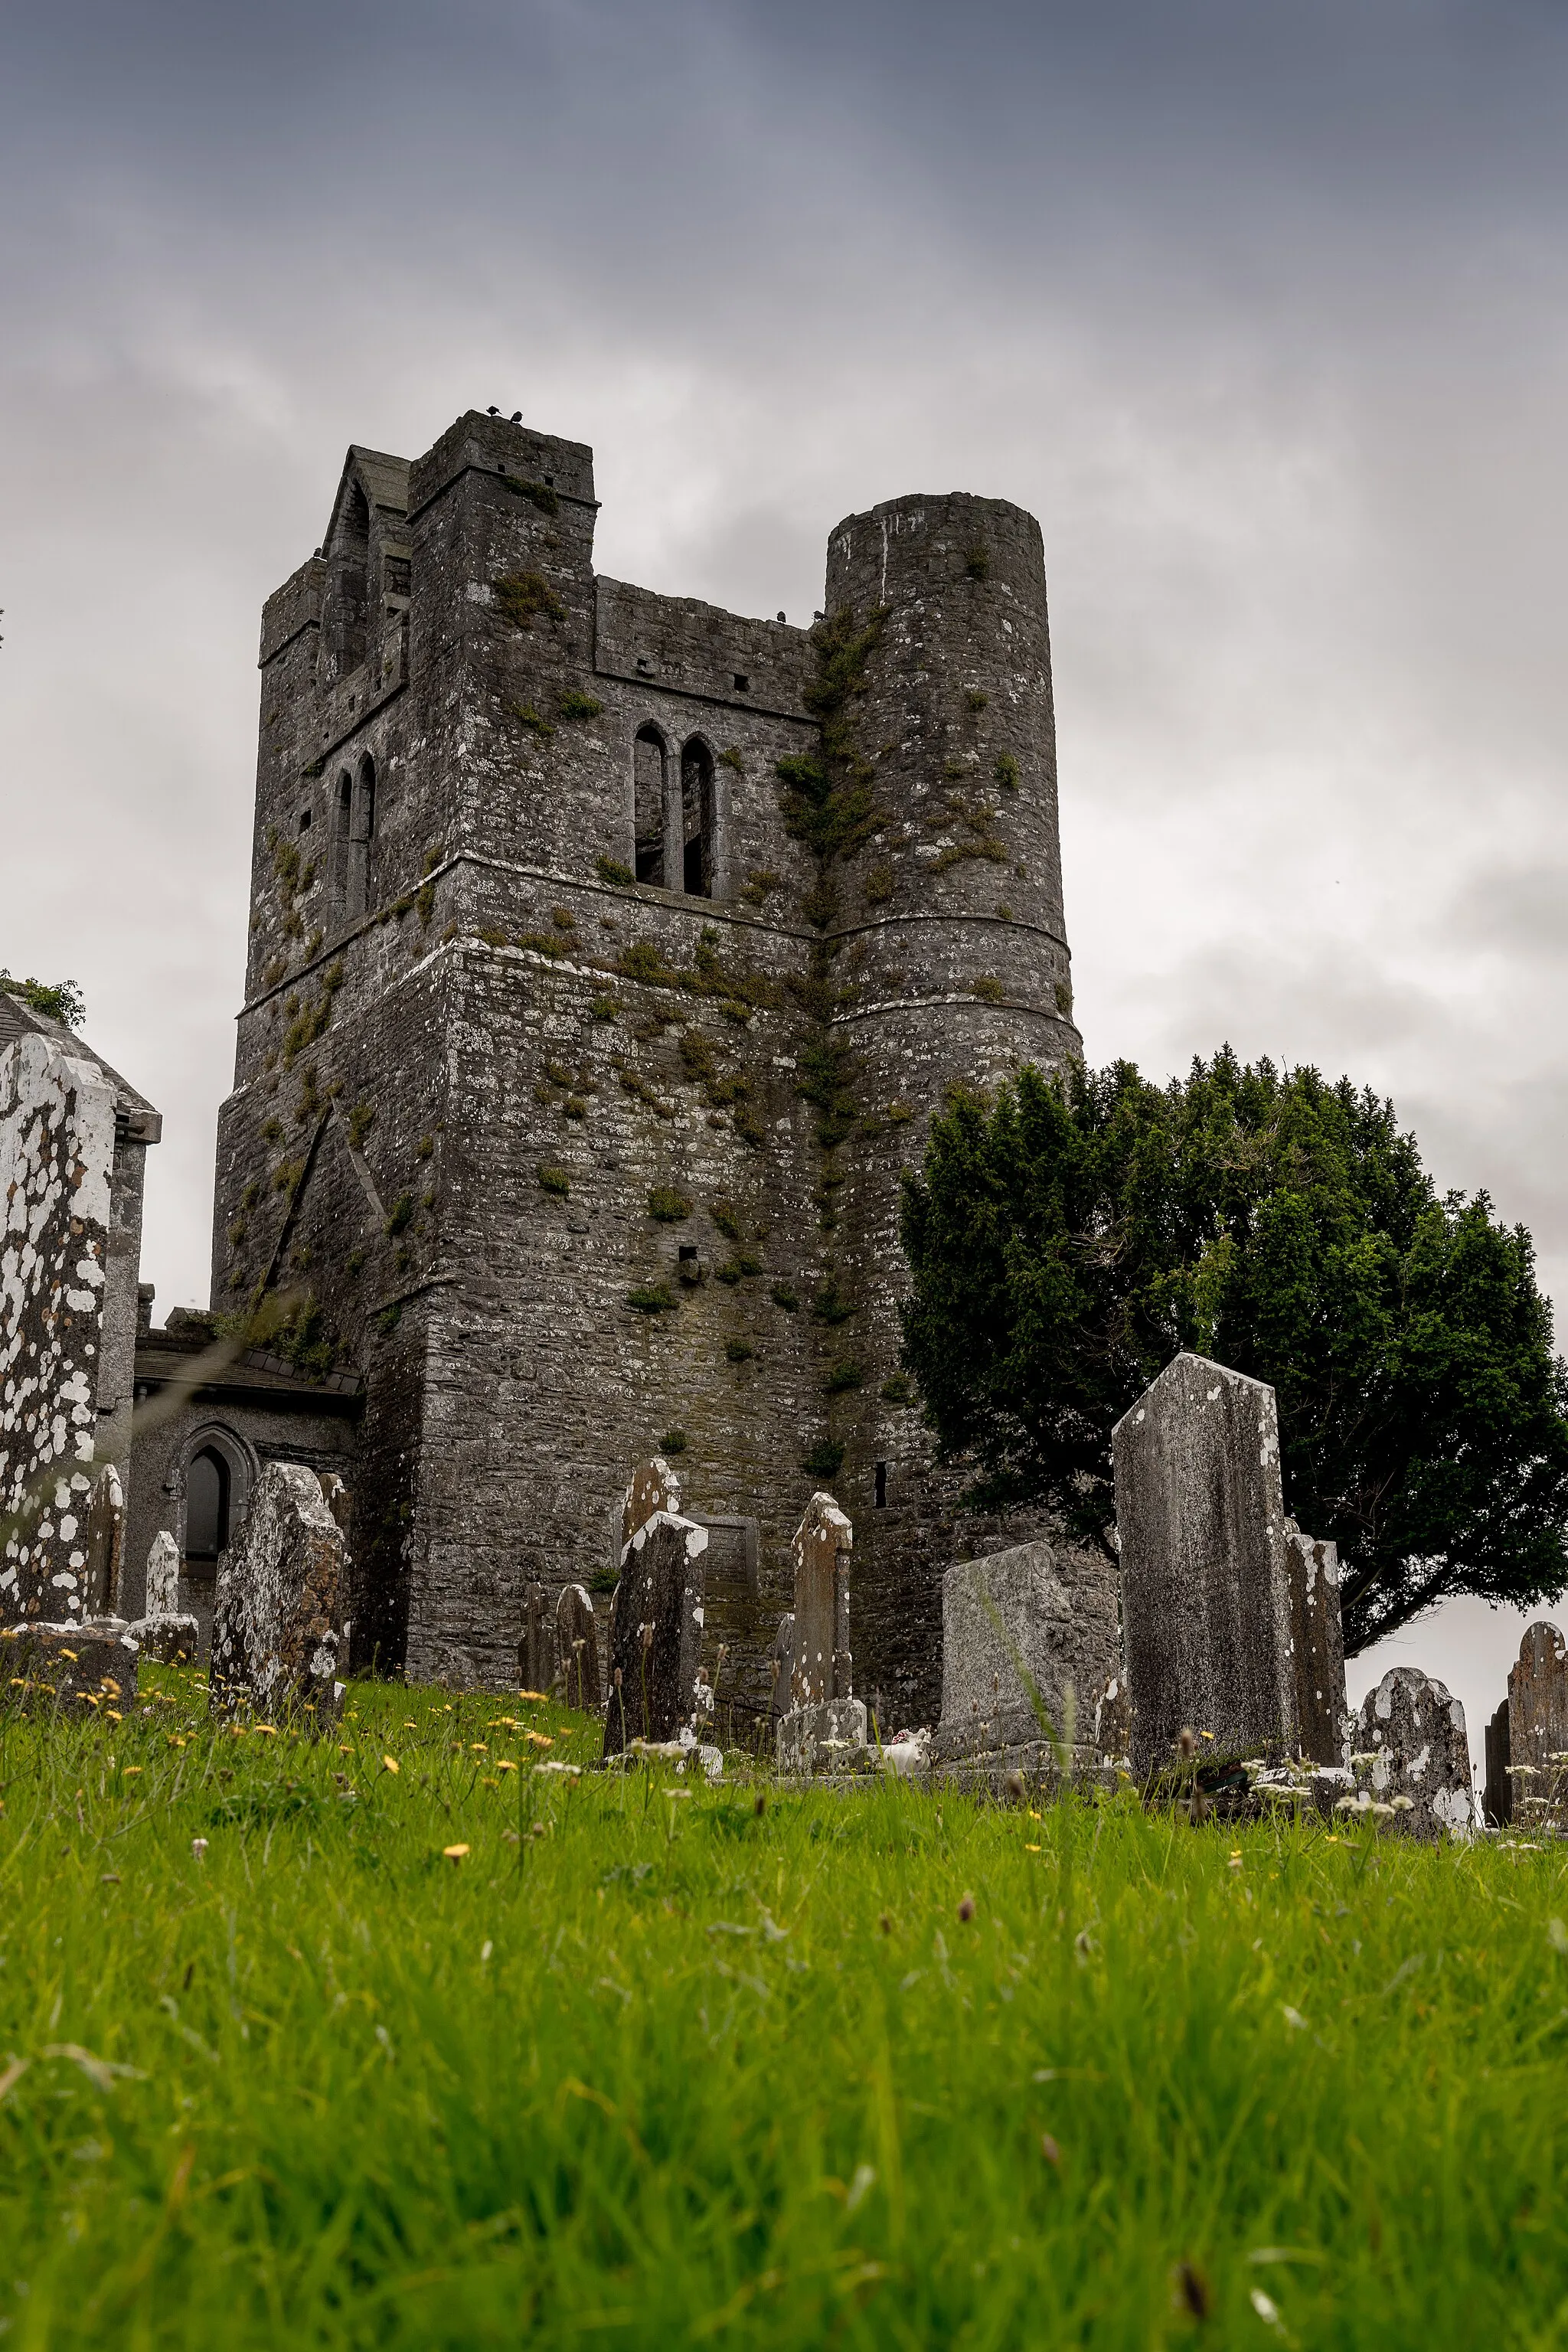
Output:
[[209, 1463, 343, 1729]]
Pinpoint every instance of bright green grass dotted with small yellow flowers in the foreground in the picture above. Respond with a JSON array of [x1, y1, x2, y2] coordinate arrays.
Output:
[[0, 1668, 1568, 2352]]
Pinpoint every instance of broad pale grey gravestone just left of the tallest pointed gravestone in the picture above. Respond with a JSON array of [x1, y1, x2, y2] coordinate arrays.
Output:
[[931, 1543, 1119, 1764]]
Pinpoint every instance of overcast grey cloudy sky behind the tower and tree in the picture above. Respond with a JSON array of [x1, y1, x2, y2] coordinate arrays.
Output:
[[0, 0, 1568, 1740]]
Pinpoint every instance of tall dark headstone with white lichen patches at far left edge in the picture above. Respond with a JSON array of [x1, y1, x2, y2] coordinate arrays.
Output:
[[0, 1035, 115, 1623]]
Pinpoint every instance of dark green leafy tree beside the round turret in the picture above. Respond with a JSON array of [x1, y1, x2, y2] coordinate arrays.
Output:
[[903, 1047, 1568, 1651]]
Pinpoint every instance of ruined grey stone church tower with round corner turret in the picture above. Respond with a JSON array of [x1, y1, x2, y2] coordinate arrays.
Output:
[[214, 414, 1079, 1722]]
